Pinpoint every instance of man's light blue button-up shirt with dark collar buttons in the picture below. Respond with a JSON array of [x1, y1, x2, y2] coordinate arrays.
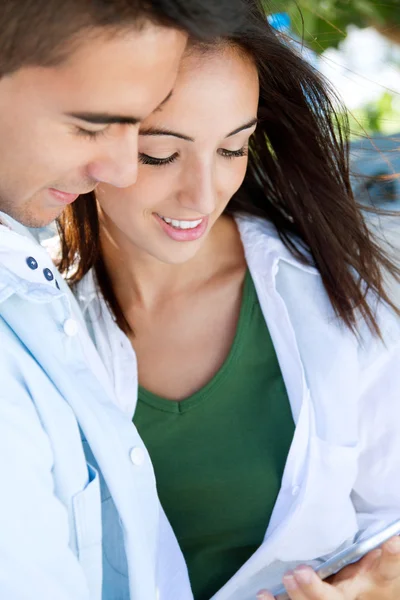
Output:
[[0, 226, 192, 600]]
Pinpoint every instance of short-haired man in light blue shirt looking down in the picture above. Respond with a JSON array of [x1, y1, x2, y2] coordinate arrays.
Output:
[[0, 0, 244, 600]]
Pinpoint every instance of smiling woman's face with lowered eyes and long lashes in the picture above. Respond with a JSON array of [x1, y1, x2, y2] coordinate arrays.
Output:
[[97, 48, 259, 264]]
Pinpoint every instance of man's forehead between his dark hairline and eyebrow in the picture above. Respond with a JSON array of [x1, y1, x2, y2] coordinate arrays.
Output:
[[0, 26, 183, 125]]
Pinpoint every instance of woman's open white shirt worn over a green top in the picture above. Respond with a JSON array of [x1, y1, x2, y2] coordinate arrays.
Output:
[[78, 217, 400, 600]]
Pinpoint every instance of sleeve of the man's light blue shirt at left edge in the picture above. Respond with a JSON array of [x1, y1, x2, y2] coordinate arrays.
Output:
[[0, 354, 90, 600]]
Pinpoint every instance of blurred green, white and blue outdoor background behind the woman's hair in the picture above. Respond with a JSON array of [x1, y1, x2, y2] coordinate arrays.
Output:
[[266, 0, 400, 302]]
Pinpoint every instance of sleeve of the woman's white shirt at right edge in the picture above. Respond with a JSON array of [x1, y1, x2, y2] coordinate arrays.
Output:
[[353, 317, 400, 537]]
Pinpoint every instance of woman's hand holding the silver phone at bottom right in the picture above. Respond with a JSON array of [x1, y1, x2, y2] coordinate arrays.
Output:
[[257, 536, 400, 600]]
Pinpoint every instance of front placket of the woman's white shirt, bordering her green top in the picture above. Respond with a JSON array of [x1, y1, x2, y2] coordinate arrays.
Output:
[[213, 252, 313, 600]]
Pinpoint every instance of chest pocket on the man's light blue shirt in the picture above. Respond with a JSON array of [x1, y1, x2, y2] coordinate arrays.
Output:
[[72, 463, 102, 580]]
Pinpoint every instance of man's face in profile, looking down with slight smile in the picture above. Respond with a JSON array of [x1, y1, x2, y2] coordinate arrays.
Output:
[[0, 24, 186, 227]]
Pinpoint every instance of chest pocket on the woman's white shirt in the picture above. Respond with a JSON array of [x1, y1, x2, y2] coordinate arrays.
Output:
[[289, 436, 359, 560]]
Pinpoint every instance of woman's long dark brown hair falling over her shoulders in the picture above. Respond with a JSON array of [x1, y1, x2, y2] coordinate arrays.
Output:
[[58, 0, 400, 335]]
